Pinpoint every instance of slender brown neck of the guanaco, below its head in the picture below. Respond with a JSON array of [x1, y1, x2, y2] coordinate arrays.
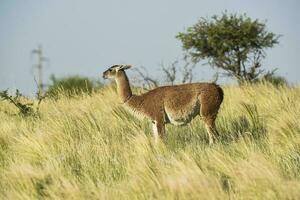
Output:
[[116, 70, 132, 103]]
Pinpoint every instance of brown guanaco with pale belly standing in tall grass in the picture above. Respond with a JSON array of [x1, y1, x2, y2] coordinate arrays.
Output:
[[103, 65, 223, 144]]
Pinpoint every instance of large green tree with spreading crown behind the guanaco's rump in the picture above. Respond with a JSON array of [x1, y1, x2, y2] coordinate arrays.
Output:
[[176, 13, 279, 83]]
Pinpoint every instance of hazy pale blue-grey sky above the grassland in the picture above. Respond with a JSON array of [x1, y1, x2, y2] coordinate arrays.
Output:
[[0, 0, 300, 95]]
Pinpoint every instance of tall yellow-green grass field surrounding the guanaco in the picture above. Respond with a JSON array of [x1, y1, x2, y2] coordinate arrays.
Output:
[[0, 84, 300, 199]]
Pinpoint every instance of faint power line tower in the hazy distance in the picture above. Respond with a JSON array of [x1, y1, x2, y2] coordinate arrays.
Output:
[[31, 45, 48, 96]]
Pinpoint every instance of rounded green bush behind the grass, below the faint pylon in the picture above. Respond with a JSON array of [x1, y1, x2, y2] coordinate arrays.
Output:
[[47, 75, 102, 98]]
